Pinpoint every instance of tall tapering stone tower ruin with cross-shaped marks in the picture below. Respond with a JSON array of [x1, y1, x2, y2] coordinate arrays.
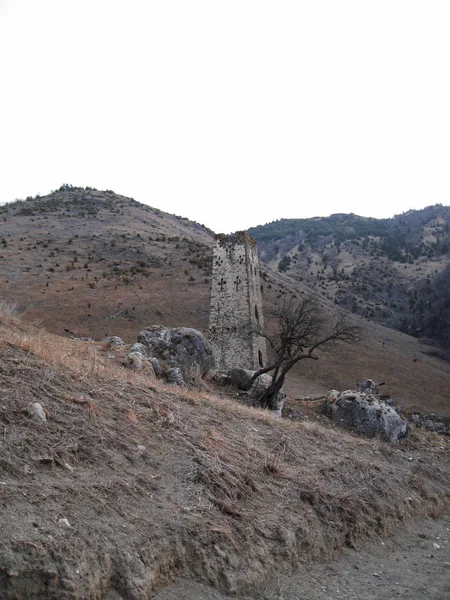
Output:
[[209, 231, 267, 370]]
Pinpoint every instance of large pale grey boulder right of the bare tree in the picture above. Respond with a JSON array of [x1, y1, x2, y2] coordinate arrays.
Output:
[[324, 390, 409, 442]]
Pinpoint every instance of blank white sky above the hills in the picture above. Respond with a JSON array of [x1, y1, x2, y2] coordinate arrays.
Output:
[[0, 0, 450, 232]]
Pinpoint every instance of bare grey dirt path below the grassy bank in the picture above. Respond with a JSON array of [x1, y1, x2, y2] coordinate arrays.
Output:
[[155, 516, 450, 600]]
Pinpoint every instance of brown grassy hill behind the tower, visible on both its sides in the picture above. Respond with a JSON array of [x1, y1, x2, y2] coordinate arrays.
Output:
[[0, 186, 450, 416]]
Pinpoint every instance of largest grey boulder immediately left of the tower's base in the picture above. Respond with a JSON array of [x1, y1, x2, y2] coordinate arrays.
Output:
[[138, 325, 214, 380]]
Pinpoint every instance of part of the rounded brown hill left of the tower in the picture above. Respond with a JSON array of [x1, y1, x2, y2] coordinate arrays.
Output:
[[0, 186, 212, 339]]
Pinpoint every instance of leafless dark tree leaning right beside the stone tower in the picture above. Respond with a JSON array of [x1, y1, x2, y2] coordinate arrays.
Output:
[[252, 296, 361, 409]]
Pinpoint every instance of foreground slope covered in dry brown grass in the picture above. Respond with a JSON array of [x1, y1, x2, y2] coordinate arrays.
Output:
[[0, 303, 450, 600]]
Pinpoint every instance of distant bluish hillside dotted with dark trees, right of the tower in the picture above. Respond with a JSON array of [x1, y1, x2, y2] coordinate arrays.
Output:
[[249, 205, 450, 349]]
